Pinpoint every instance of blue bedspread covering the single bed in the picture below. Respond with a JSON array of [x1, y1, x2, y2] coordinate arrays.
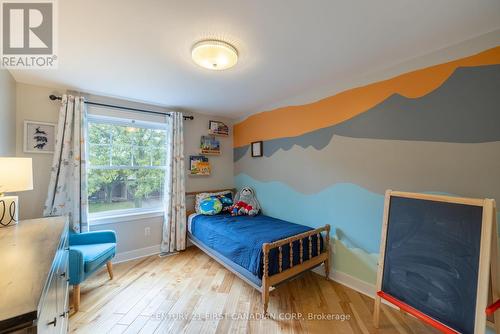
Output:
[[191, 214, 323, 278]]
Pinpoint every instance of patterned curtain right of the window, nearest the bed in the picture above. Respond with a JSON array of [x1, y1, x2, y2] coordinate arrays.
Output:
[[161, 112, 186, 253]]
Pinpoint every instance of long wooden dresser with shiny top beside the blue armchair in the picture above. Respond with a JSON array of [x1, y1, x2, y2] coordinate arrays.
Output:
[[0, 217, 69, 333]]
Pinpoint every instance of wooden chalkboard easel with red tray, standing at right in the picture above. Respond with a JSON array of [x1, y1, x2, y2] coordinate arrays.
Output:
[[373, 190, 500, 334]]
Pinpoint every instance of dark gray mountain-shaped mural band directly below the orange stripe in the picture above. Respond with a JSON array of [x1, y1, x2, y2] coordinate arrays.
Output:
[[234, 65, 500, 161]]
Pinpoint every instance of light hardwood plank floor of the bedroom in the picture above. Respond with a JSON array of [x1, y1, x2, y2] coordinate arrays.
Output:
[[70, 247, 437, 334]]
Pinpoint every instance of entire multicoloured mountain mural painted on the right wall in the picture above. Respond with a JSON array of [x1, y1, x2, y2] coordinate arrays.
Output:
[[234, 47, 500, 284]]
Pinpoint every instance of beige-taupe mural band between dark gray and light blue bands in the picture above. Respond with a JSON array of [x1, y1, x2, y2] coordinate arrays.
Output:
[[234, 136, 500, 201]]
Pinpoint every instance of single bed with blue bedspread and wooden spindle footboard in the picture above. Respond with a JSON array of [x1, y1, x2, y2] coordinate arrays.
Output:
[[186, 191, 330, 313]]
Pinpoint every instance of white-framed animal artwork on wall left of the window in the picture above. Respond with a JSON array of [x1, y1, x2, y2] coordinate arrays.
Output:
[[24, 121, 56, 153]]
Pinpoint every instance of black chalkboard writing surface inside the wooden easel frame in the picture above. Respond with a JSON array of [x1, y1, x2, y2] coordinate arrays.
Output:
[[382, 196, 483, 333]]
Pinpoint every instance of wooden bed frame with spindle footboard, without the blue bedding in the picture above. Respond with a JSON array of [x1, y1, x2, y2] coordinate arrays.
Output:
[[186, 189, 330, 314]]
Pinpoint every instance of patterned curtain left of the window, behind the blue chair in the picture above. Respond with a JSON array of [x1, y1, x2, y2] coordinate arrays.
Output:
[[43, 95, 89, 232]]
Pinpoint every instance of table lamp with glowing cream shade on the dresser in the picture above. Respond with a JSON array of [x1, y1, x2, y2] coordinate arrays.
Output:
[[0, 158, 33, 227]]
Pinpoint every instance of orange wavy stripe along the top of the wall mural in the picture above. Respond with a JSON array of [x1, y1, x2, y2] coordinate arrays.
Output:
[[233, 46, 500, 147]]
